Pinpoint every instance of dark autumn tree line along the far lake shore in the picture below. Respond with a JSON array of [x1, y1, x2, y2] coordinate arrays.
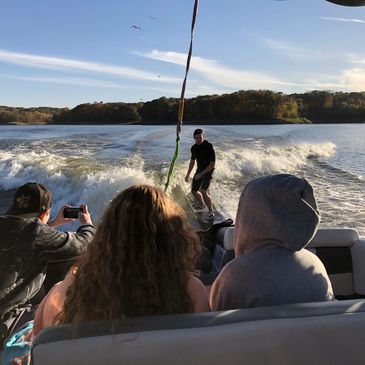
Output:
[[0, 90, 365, 124]]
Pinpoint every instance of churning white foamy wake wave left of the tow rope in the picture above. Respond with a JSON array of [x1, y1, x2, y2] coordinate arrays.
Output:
[[0, 152, 154, 220]]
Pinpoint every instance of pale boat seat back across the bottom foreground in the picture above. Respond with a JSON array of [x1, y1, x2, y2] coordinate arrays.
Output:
[[32, 300, 365, 365]]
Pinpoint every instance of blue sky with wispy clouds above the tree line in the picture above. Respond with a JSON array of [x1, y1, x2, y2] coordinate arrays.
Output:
[[0, 0, 365, 108]]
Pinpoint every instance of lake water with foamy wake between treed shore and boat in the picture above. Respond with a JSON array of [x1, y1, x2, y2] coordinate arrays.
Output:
[[0, 124, 365, 236]]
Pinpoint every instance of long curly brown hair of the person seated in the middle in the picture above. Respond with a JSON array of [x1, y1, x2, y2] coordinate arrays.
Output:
[[58, 185, 201, 323]]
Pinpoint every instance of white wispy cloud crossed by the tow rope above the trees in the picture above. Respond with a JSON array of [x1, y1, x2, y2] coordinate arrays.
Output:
[[140, 50, 299, 90]]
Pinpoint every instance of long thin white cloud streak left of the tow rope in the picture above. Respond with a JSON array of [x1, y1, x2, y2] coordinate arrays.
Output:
[[0, 50, 181, 83]]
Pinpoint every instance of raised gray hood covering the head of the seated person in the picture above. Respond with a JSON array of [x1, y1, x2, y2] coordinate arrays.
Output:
[[235, 174, 320, 256]]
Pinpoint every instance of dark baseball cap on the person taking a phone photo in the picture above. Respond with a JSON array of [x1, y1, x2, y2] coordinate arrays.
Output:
[[7, 182, 52, 217]]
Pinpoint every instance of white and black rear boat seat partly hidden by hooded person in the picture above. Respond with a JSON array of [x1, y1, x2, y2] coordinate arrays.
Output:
[[210, 227, 365, 299]]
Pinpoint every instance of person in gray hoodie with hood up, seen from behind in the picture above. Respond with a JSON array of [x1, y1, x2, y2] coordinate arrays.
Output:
[[210, 174, 334, 310]]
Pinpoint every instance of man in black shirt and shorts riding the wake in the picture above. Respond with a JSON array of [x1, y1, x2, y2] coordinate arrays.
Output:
[[185, 128, 215, 218]]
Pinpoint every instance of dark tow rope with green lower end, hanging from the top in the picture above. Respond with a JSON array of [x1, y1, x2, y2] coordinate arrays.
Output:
[[165, 0, 199, 191]]
